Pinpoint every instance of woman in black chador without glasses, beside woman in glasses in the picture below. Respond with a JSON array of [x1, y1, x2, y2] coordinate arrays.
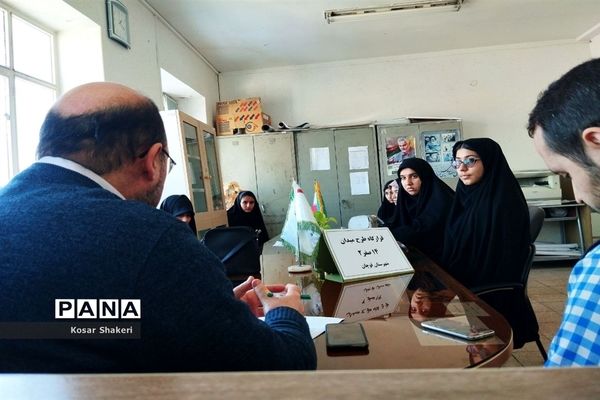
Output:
[[389, 158, 454, 262]]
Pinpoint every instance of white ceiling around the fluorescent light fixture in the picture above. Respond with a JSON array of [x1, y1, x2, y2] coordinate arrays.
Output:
[[141, 0, 600, 72]]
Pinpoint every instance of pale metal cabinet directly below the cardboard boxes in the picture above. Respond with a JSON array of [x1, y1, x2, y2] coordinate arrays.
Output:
[[217, 133, 296, 236]]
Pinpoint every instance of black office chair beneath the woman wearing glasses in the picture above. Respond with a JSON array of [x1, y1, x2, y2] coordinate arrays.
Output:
[[472, 206, 548, 361]]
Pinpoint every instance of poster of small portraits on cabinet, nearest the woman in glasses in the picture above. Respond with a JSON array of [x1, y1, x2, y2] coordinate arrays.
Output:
[[421, 129, 459, 179]]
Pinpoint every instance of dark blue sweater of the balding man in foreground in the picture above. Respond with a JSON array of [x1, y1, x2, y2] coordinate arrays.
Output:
[[0, 163, 316, 373]]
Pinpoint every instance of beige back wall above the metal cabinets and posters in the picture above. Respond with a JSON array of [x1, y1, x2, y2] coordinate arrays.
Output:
[[220, 42, 591, 170]]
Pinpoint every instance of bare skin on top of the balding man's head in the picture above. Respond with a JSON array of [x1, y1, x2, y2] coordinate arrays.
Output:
[[52, 82, 147, 117]]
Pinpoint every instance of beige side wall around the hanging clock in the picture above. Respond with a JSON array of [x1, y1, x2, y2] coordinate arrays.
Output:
[[63, 0, 219, 125]]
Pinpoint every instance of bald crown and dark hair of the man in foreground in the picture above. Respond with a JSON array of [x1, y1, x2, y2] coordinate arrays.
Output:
[[38, 82, 166, 175]]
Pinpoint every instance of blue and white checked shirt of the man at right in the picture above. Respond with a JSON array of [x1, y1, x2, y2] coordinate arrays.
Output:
[[545, 242, 600, 367]]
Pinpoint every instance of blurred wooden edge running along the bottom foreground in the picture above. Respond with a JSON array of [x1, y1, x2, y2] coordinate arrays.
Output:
[[0, 367, 600, 400]]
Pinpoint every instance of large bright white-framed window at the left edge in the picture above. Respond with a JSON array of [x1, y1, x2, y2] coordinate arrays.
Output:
[[0, 8, 56, 187]]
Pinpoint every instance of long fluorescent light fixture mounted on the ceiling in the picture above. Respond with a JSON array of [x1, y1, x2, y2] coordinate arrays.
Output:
[[325, 0, 464, 24]]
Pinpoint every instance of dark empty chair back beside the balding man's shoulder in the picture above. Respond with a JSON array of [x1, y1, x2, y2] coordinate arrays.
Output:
[[202, 226, 260, 286]]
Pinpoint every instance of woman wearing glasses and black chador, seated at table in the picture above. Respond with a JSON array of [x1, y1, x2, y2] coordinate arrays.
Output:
[[442, 138, 530, 288]]
